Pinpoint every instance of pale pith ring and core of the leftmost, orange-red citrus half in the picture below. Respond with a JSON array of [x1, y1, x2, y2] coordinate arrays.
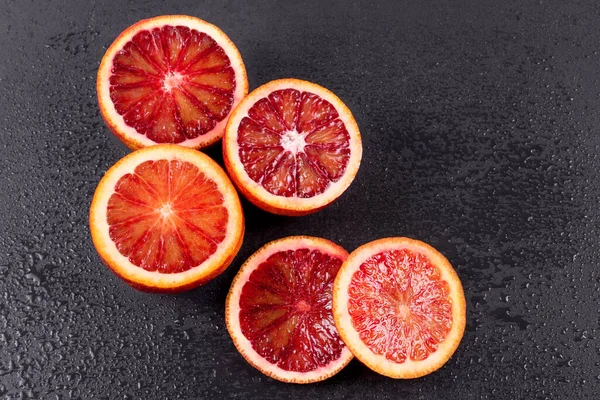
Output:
[[90, 145, 243, 288]]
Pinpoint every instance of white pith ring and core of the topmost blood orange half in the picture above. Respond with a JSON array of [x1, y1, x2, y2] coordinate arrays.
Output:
[[97, 15, 248, 147]]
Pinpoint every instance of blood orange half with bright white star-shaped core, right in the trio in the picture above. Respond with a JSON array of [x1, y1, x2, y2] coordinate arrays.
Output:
[[223, 79, 362, 215]]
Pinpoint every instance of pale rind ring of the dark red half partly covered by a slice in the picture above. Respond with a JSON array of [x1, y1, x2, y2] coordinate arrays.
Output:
[[225, 236, 353, 383]]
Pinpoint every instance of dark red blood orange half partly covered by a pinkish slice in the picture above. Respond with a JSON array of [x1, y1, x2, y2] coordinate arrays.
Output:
[[225, 236, 352, 383]]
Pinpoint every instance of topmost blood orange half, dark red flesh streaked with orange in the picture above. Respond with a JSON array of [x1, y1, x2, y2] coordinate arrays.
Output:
[[97, 15, 248, 149]]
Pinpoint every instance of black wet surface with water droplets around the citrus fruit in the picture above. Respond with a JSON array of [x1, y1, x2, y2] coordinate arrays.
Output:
[[0, 0, 600, 399]]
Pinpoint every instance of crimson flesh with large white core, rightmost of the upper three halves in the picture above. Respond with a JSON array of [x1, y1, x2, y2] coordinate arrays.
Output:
[[238, 89, 350, 197]]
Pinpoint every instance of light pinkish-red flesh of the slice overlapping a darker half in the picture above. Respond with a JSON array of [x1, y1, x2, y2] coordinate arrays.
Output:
[[348, 249, 452, 363]]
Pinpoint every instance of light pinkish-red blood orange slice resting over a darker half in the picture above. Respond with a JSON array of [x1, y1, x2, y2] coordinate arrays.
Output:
[[333, 238, 466, 379]]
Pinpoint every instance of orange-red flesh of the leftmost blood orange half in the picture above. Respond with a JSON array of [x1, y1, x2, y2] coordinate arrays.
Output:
[[107, 160, 228, 274]]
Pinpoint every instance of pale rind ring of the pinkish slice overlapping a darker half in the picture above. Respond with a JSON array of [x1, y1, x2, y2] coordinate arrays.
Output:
[[333, 238, 465, 378]]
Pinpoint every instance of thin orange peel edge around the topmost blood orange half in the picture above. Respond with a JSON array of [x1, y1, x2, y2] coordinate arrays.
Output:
[[96, 15, 249, 150]]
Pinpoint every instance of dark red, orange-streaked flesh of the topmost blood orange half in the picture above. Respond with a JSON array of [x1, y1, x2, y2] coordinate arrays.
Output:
[[110, 25, 236, 143]]
